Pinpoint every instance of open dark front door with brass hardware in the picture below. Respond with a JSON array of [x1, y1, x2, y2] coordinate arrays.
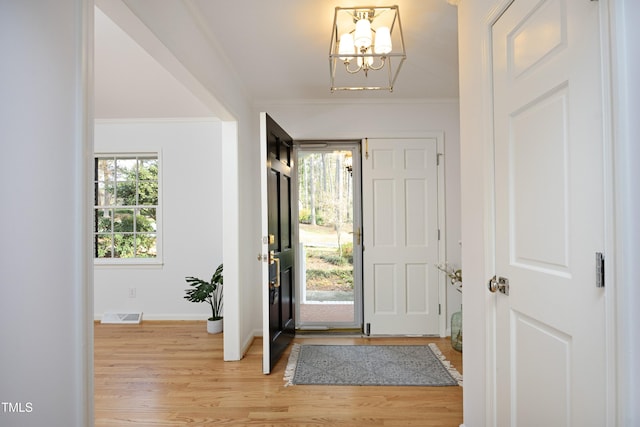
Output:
[[263, 114, 295, 373]]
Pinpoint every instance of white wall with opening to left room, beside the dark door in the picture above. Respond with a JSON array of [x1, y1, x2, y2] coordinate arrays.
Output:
[[96, 0, 252, 360]]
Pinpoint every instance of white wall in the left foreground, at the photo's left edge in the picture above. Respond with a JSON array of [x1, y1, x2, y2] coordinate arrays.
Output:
[[0, 0, 93, 427]]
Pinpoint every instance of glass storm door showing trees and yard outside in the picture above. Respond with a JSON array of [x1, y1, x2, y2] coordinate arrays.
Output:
[[296, 142, 362, 330]]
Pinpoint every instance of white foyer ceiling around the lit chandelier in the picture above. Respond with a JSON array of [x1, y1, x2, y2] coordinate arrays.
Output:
[[96, 0, 458, 114]]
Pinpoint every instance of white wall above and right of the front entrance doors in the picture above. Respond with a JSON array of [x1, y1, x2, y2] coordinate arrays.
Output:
[[256, 100, 462, 324]]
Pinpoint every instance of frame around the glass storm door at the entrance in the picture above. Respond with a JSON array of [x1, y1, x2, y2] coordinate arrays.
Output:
[[291, 139, 364, 330]]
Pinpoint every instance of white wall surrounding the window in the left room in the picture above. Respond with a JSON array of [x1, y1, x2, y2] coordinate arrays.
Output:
[[94, 119, 224, 320]]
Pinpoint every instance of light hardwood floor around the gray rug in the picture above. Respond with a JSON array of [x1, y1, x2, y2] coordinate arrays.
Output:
[[94, 321, 462, 427]]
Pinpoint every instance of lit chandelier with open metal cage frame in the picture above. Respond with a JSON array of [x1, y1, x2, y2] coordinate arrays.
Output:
[[329, 6, 407, 92]]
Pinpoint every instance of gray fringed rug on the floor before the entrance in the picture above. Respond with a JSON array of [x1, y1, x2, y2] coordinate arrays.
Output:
[[284, 344, 462, 387]]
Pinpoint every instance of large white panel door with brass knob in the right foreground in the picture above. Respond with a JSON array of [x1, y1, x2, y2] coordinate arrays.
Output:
[[492, 0, 607, 427]]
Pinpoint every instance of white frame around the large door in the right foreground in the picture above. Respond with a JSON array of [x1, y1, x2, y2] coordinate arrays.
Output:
[[482, 0, 620, 426]]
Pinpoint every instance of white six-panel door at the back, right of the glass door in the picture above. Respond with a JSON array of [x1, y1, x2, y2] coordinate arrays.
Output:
[[362, 139, 439, 335]]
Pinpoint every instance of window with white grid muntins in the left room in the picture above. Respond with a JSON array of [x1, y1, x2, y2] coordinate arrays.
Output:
[[94, 154, 159, 262]]
